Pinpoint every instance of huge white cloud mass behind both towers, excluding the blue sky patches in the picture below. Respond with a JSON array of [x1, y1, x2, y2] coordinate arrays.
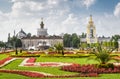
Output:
[[0, 0, 120, 40]]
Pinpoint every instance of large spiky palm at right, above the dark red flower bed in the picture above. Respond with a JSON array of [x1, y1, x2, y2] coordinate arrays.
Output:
[[91, 44, 116, 64]]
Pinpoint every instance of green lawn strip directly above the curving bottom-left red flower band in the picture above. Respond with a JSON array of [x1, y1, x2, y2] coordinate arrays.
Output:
[[3, 59, 77, 75]]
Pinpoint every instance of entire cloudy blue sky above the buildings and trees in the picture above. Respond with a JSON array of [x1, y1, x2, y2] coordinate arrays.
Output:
[[0, 0, 120, 41]]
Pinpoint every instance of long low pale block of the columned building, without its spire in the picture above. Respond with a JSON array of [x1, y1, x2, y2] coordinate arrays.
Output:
[[21, 36, 63, 49]]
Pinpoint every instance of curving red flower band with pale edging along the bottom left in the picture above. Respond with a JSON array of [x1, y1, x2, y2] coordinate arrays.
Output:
[[0, 69, 86, 78]]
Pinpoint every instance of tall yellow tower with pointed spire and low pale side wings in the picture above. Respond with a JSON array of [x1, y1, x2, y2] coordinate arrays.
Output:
[[80, 15, 111, 44]]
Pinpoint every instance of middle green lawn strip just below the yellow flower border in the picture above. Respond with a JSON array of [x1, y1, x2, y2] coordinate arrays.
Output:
[[36, 57, 98, 64]]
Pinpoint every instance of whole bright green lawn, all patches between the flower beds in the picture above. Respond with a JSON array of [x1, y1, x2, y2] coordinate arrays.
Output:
[[0, 54, 120, 79]]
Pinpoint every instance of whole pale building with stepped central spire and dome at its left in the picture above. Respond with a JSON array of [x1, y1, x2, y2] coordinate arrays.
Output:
[[18, 20, 63, 50]]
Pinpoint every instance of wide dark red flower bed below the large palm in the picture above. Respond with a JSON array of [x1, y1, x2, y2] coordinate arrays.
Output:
[[61, 64, 120, 76]]
